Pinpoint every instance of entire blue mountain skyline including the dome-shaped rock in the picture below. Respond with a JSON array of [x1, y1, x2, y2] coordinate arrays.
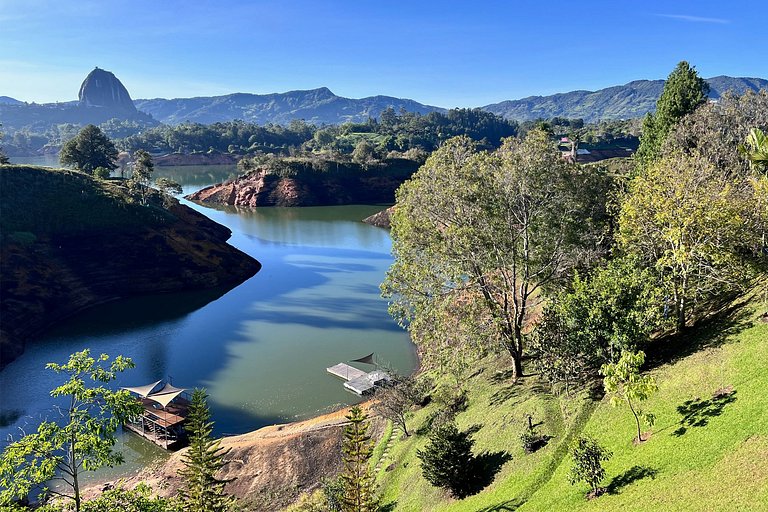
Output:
[[0, 68, 768, 132]]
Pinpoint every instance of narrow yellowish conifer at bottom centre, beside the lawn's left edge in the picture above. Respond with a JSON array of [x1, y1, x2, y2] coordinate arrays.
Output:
[[341, 406, 378, 512]]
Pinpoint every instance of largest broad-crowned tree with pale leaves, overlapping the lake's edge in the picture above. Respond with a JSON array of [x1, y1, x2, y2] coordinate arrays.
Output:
[[382, 130, 604, 376]]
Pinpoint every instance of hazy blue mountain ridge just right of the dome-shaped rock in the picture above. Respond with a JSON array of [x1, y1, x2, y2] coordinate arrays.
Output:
[[134, 87, 445, 124]]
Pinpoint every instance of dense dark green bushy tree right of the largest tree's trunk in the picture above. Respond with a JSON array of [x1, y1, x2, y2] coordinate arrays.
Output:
[[530, 257, 663, 392]]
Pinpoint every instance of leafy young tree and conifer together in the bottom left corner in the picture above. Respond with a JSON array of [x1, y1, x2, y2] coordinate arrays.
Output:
[[0, 350, 236, 512]]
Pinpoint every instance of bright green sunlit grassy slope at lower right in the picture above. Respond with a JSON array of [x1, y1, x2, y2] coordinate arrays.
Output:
[[379, 292, 768, 512]]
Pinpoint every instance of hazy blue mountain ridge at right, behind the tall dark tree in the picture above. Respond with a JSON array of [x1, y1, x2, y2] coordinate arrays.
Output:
[[483, 76, 768, 123]]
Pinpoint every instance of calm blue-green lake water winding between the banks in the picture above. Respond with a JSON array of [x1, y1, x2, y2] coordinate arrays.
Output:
[[0, 159, 417, 484]]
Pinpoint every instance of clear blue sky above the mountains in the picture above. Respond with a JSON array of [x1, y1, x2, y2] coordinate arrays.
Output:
[[0, 0, 768, 107]]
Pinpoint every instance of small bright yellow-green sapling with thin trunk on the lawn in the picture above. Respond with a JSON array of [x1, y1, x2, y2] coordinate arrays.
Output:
[[600, 351, 659, 442]]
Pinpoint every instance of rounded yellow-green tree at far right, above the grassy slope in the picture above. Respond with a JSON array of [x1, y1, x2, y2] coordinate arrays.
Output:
[[618, 153, 759, 332]]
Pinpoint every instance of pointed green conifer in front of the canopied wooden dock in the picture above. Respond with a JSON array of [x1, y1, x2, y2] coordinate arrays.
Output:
[[179, 389, 234, 512]]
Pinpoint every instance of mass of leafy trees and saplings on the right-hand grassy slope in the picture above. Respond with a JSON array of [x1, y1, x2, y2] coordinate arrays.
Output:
[[382, 62, 768, 493]]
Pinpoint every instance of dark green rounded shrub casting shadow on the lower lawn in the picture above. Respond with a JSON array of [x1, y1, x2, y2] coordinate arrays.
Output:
[[416, 422, 477, 498]]
